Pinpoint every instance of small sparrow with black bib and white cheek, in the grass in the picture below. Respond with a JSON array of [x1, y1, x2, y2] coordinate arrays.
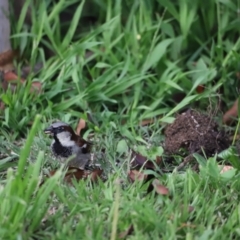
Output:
[[44, 122, 92, 169]]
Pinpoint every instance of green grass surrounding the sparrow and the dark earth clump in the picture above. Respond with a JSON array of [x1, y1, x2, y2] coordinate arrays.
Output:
[[0, 0, 240, 240]]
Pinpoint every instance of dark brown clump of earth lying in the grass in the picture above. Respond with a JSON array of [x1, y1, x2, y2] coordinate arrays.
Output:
[[165, 109, 230, 157]]
